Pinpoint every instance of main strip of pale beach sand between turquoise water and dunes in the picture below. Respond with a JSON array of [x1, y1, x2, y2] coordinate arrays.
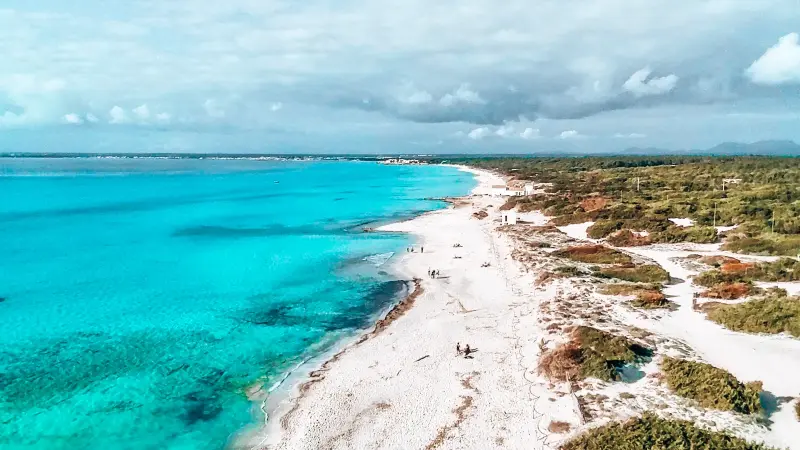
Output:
[[250, 169, 568, 449]]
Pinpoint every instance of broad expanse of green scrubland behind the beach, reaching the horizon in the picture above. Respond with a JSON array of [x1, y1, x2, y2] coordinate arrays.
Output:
[[438, 156, 800, 256]]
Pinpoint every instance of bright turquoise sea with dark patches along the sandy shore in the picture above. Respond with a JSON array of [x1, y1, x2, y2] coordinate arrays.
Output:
[[0, 159, 474, 450]]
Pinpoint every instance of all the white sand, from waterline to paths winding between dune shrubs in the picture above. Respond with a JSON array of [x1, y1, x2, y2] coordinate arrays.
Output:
[[247, 168, 800, 450]]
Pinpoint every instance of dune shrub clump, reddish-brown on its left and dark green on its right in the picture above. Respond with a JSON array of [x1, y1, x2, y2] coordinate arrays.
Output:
[[539, 326, 653, 381]]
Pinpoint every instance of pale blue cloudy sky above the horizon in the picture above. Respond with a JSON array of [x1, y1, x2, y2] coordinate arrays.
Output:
[[0, 0, 800, 153]]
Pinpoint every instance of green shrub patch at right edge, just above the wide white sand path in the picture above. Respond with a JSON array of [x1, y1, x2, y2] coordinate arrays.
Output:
[[706, 295, 800, 338]]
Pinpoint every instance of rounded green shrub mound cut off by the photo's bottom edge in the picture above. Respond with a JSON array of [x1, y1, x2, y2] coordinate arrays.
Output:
[[561, 413, 770, 450]]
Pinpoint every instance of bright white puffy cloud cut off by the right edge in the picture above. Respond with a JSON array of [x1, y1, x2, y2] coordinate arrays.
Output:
[[745, 33, 800, 85]]
